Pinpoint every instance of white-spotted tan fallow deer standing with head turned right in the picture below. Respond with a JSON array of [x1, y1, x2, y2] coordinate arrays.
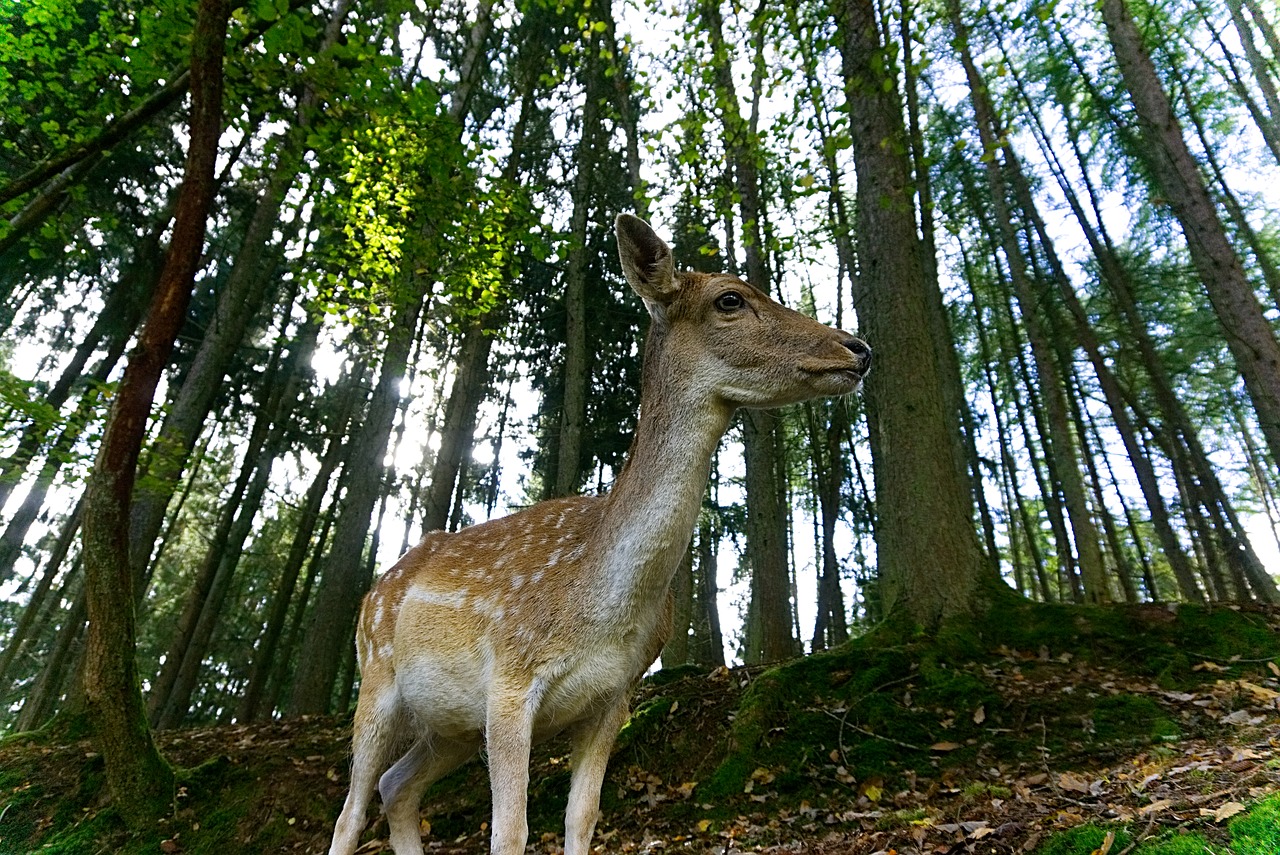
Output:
[[329, 214, 870, 855]]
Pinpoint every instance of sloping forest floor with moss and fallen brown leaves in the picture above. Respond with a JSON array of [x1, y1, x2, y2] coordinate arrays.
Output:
[[0, 607, 1280, 855]]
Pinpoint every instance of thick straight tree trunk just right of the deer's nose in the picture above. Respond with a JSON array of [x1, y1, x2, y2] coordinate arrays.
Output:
[[836, 0, 986, 630]]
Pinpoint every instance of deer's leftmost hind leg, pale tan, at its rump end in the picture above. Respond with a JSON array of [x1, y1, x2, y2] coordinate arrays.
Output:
[[329, 673, 406, 855]]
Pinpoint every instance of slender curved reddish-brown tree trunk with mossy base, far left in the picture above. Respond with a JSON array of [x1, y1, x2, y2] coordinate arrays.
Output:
[[83, 0, 230, 829]]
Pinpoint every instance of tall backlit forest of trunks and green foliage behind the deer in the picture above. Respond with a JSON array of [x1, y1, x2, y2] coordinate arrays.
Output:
[[0, 0, 1280, 819]]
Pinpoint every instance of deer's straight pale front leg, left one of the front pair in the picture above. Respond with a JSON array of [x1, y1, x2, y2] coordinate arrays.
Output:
[[485, 685, 541, 855]]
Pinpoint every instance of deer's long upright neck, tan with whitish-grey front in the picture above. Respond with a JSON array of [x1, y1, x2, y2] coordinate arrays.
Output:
[[596, 333, 733, 622]]
